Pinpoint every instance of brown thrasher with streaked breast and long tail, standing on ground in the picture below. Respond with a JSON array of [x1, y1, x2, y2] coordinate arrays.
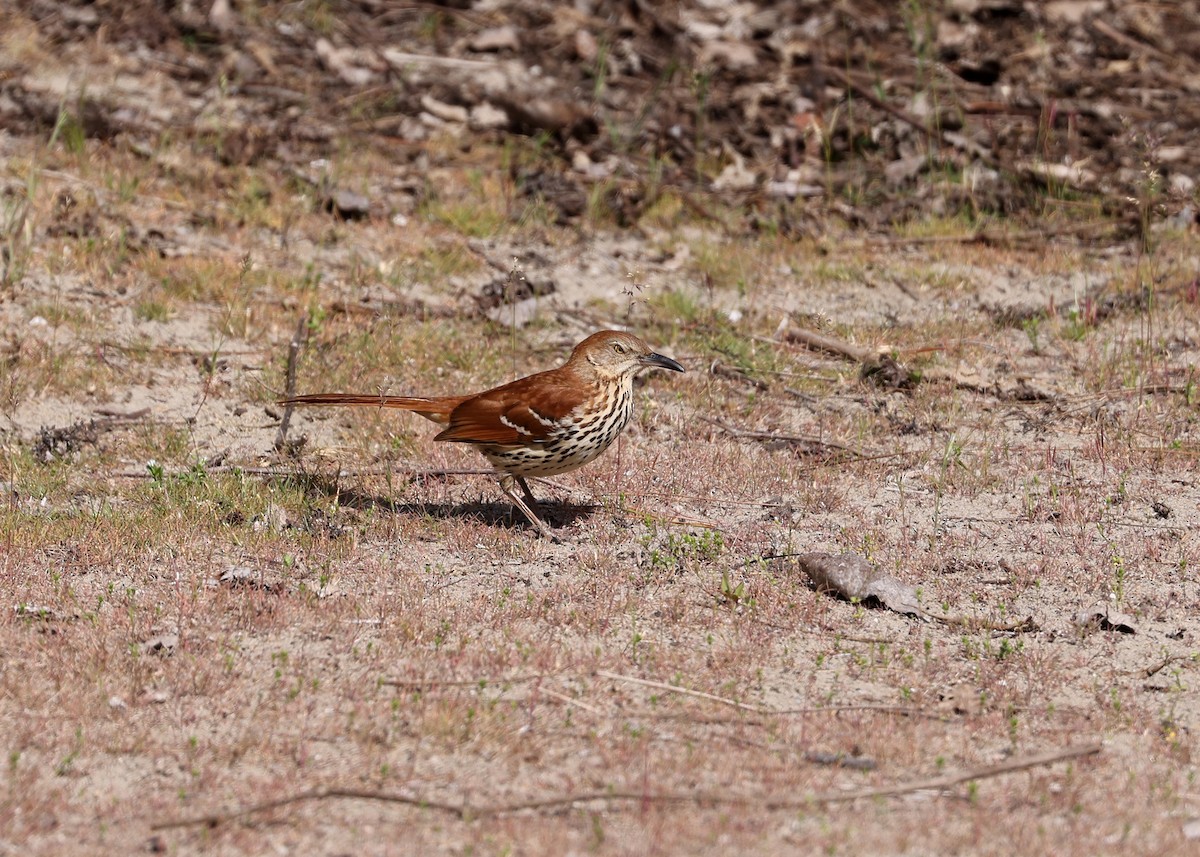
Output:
[[281, 330, 683, 537]]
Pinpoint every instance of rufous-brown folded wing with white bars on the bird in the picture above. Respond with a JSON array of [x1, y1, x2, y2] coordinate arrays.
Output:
[[434, 370, 587, 444]]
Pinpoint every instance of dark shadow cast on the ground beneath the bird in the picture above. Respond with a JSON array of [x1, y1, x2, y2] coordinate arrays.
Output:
[[286, 473, 599, 529]]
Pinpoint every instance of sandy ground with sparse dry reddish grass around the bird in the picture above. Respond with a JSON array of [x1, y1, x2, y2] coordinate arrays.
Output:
[[0, 110, 1200, 855]]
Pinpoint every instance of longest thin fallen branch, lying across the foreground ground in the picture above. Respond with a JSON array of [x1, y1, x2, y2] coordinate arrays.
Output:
[[150, 739, 1100, 831]]
